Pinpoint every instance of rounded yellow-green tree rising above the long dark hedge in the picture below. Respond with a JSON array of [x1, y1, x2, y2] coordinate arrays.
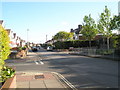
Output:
[[53, 31, 73, 41]]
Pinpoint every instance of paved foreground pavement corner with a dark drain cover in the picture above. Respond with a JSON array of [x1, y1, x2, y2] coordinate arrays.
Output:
[[16, 72, 72, 90]]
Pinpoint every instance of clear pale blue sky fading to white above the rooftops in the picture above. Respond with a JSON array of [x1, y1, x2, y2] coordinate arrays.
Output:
[[0, 0, 119, 43]]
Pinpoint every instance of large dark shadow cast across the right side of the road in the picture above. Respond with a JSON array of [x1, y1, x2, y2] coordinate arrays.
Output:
[[41, 52, 118, 90]]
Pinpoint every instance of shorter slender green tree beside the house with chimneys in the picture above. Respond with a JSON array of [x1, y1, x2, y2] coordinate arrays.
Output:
[[80, 14, 97, 48]]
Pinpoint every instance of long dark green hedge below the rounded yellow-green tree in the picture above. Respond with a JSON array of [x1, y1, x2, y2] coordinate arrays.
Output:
[[54, 40, 99, 49]]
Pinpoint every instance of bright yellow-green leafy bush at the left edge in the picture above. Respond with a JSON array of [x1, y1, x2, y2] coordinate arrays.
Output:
[[0, 25, 10, 79]]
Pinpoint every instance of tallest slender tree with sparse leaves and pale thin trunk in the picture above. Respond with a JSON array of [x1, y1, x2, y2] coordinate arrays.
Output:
[[98, 6, 112, 50]]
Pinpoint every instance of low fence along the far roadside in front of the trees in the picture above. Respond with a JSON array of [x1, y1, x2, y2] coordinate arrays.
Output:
[[70, 48, 120, 60]]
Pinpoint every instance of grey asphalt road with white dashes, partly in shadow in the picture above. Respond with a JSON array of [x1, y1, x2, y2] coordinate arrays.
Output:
[[5, 49, 118, 88]]
